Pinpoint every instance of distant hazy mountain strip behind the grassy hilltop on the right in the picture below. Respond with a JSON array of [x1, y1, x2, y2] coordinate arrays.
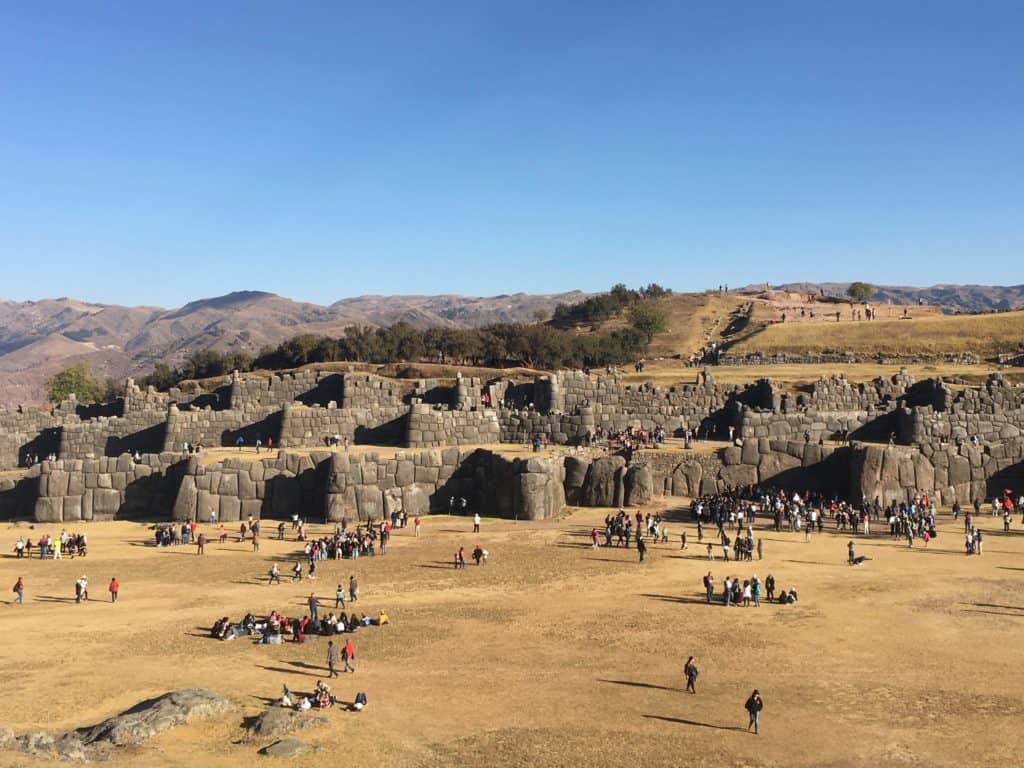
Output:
[[750, 283, 1024, 313]]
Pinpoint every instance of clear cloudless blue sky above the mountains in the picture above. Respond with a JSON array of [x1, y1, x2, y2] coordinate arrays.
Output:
[[0, 0, 1024, 306]]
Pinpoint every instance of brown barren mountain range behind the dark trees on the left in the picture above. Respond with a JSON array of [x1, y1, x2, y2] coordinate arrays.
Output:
[[0, 291, 589, 406]]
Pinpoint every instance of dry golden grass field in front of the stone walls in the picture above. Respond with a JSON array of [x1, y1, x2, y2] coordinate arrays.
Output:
[[0, 500, 1024, 768]]
